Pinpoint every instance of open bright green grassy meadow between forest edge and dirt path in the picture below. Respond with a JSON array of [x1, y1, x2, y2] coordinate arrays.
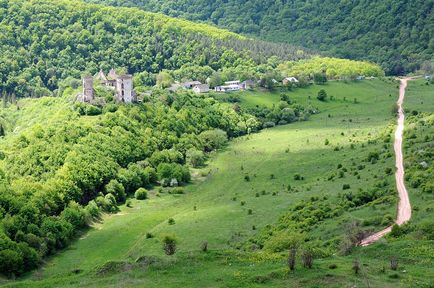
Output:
[[5, 80, 432, 287]]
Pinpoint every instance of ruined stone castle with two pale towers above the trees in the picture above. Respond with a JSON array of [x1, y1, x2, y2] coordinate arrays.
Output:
[[78, 69, 137, 103]]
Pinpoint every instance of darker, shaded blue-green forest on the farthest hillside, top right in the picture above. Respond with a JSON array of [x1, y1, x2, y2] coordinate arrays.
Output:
[[87, 0, 434, 75]]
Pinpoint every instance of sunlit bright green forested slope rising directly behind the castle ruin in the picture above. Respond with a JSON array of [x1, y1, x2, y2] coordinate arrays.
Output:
[[0, 0, 310, 97]]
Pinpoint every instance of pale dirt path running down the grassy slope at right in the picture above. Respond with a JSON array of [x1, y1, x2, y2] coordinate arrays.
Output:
[[360, 78, 412, 246]]
